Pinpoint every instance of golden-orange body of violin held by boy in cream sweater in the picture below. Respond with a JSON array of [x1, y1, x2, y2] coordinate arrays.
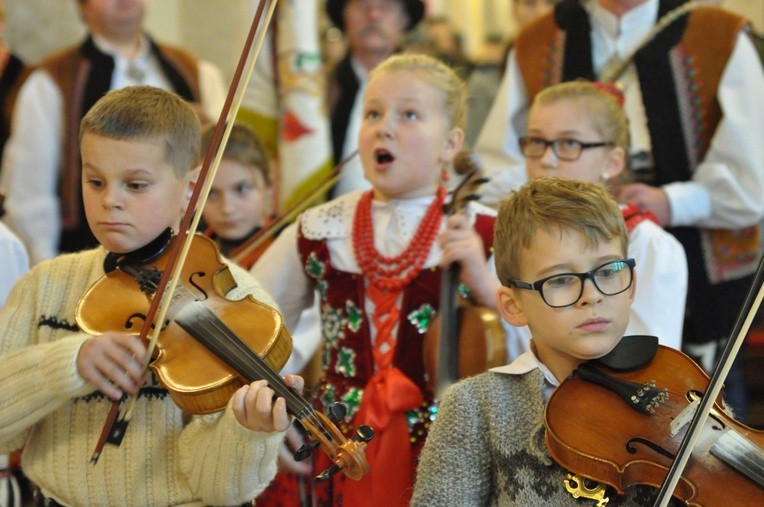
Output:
[[77, 234, 292, 414]]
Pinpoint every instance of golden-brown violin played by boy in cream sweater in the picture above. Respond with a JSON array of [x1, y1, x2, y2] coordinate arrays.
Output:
[[76, 234, 373, 480]]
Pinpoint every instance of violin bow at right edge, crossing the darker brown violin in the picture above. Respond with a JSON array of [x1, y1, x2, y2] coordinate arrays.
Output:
[[655, 250, 764, 507]]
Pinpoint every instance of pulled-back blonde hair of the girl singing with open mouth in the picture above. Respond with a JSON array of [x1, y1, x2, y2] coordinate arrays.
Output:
[[369, 53, 467, 129]]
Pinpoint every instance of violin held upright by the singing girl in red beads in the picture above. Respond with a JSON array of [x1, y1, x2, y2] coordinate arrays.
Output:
[[423, 159, 506, 395]]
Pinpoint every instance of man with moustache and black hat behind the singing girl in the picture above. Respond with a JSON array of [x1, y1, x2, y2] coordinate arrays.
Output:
[[326, 0, 425, 197]]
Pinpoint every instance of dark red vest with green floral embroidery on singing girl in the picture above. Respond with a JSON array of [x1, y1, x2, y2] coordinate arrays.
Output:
[[298, 215, 496, 447]]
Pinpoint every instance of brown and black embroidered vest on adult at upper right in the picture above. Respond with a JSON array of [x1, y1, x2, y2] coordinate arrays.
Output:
[[514, 0, 760, 283]]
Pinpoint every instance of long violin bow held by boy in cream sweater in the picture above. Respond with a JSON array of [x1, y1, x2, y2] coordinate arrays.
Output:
[[90, 0, 278, 464]]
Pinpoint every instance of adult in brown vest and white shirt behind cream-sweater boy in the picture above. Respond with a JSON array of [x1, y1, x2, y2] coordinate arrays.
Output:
[[0, 0, 225, 262]]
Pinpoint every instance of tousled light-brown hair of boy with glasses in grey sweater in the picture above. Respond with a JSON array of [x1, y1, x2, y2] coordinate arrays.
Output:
[[493, 177, 629, 282]]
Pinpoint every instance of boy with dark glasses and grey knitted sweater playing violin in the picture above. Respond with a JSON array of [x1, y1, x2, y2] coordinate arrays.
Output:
[[412, 178, 672, 506]]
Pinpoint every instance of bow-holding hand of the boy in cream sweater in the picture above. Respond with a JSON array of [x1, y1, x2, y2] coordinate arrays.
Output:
[[77, 333, 146, 400]]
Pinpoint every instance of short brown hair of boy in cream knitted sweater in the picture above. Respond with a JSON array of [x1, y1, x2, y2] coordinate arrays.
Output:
[[80, 86, 201, 176]]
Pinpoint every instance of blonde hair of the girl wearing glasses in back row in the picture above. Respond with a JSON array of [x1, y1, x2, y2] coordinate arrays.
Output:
[[532, 80, 629, 169]]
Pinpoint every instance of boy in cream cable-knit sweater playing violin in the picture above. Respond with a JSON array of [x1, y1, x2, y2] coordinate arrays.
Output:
[[0, 87, 302, 505]]
